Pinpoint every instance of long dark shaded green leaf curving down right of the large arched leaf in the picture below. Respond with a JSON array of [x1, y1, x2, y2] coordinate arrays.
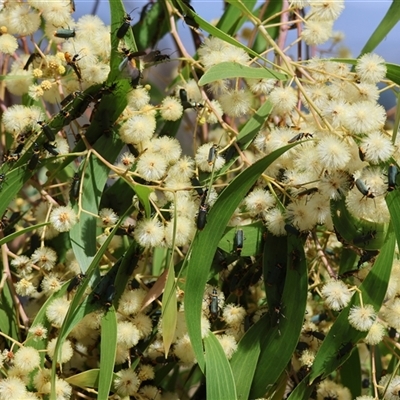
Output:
[[250, 235, 308, 398]]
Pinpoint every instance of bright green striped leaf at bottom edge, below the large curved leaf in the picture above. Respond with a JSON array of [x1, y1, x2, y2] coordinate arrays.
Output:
[[204, 332, 238, 400]]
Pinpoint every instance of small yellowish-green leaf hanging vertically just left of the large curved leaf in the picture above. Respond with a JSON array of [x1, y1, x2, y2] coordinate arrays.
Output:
[[162, 266, 178, 356]]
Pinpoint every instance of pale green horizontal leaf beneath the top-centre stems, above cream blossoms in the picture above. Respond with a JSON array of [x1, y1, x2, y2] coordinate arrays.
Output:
[[199, 62, 287, 86]]
